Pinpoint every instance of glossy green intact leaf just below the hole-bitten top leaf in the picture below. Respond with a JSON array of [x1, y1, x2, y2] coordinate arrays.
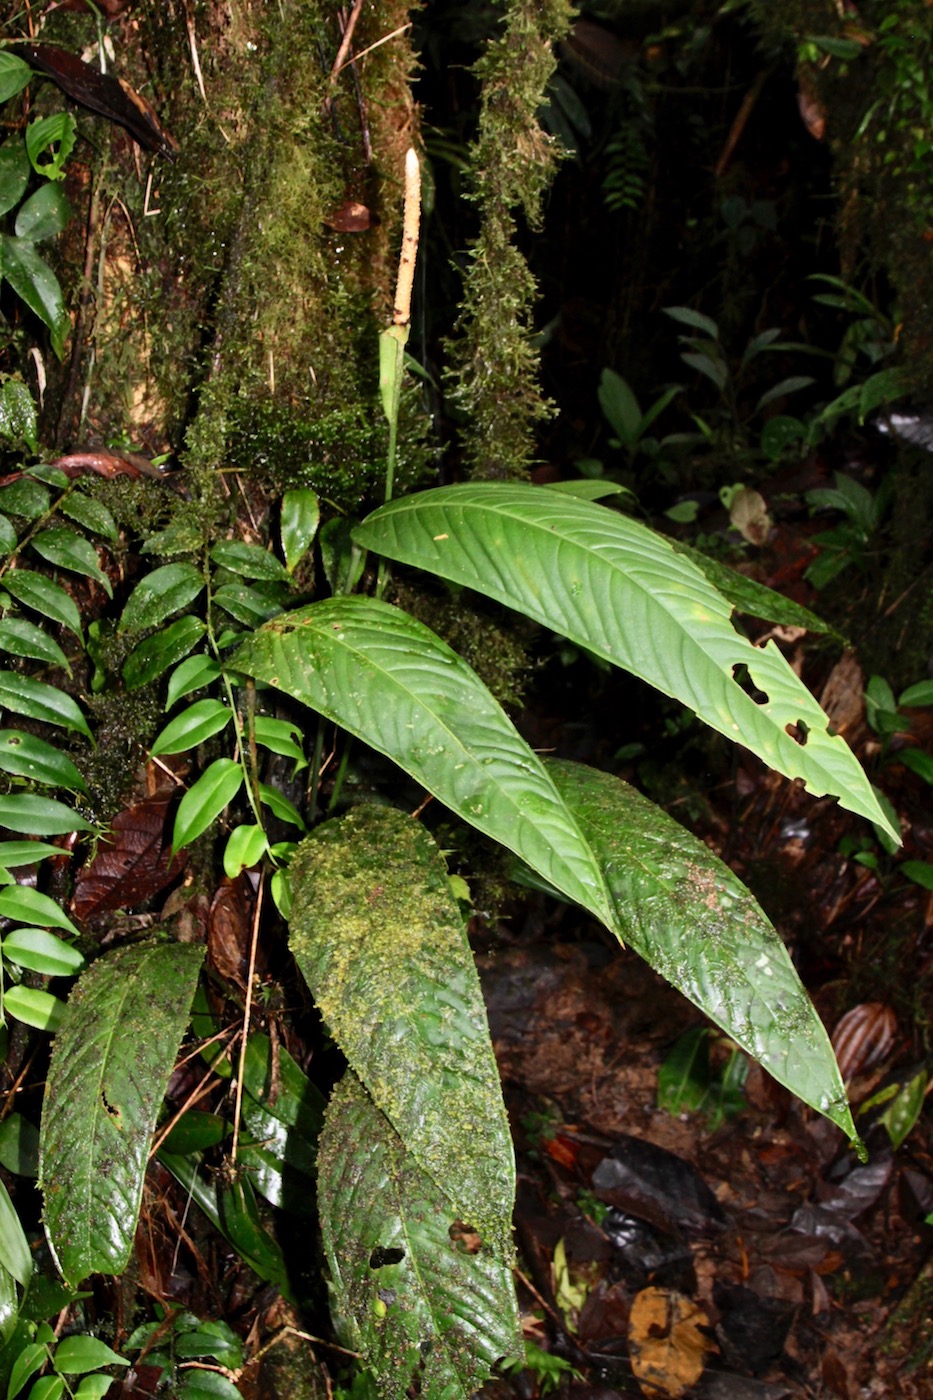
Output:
[[230, 598, 609, 921]]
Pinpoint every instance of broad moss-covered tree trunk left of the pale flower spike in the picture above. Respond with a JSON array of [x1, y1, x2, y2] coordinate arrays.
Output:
[[43, 0, 417, 515]]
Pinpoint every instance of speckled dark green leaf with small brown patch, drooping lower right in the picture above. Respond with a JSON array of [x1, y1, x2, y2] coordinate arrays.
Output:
[[548, 762, 856, 1138]]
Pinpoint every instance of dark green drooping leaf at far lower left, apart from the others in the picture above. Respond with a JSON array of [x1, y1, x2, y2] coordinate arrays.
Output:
[[39, 942, 203, 1284]]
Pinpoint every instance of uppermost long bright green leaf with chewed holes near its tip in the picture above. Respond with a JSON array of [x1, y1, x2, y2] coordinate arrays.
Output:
[[353, 483, 899, 840]]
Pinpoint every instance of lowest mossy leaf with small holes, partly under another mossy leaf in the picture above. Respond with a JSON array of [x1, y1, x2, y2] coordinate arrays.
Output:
[[318, 1072, 524, 1400]]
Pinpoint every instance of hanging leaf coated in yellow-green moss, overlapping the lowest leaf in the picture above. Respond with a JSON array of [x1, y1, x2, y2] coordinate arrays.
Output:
[[287, 806, 516, 1253]]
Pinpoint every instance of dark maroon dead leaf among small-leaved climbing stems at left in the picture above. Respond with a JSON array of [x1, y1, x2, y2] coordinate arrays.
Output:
[[71, 797, 188, 918]]
